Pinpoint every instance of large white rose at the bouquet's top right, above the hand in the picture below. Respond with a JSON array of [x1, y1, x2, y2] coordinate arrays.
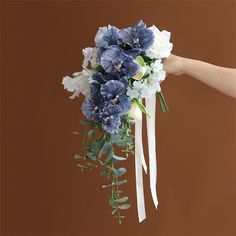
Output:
[[146, 25, 173, 59]]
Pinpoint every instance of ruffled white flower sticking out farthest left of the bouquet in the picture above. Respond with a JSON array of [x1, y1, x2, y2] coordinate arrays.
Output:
[[62, 70, 91, 99]]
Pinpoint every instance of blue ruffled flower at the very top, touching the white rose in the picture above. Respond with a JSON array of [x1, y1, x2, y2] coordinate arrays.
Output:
[[119, 21, 154, 50]]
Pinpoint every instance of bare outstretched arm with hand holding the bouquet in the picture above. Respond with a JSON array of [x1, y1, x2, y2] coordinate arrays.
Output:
[[163, 54, 236, 98]]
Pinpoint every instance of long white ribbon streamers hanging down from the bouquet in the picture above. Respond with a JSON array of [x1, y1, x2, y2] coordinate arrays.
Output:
[[135, 94, 158, 223]]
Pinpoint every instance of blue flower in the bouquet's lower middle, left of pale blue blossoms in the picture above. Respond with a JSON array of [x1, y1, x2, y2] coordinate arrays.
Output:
[[100, 80, 132, 115]]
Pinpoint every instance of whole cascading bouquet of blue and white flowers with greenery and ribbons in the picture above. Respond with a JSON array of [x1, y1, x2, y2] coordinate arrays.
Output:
[[62, 21, 173, 223]]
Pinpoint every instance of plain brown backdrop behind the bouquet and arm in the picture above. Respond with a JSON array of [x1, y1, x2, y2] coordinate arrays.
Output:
[[1, 1, 236, 235]]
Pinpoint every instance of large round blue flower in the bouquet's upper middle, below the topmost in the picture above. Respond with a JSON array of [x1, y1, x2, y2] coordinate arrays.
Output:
[[101, 46, 139, 78]]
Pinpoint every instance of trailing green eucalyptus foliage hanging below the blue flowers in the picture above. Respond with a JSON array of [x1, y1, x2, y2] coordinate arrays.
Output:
[[73, 115, 134, 224]]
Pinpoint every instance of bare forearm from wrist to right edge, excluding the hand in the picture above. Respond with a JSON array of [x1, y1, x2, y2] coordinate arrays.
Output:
[[181, 58, 236, 98]]
